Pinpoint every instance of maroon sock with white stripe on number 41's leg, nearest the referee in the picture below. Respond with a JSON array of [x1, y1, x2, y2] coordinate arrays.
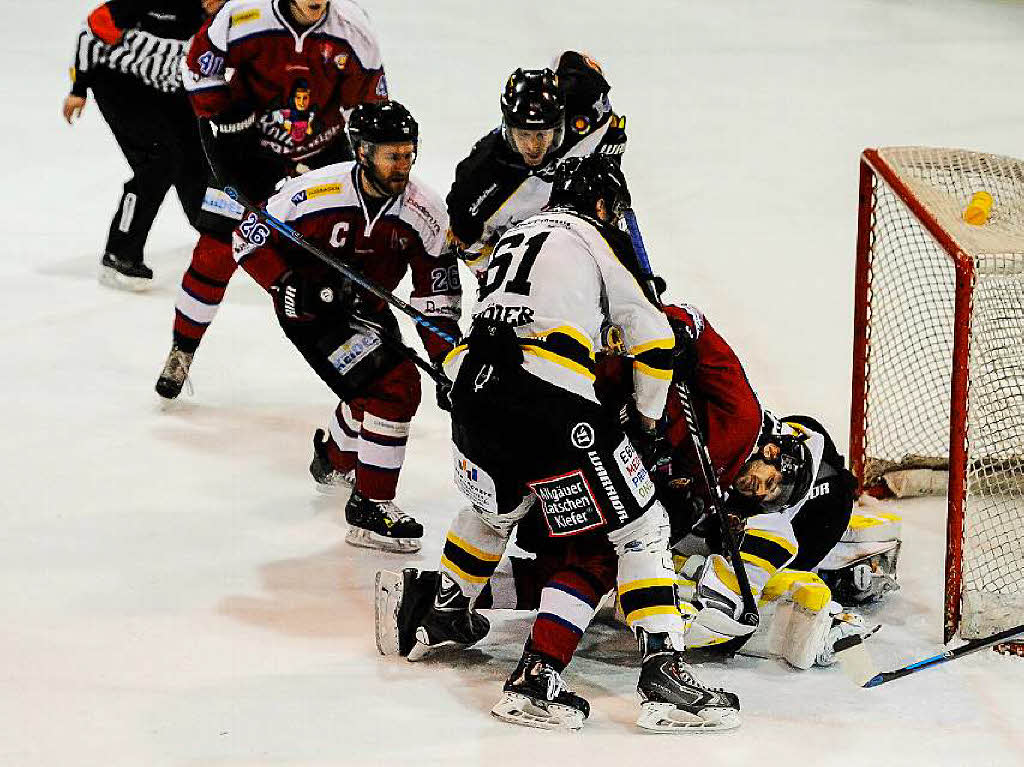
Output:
[[174, 233, 238, 353]]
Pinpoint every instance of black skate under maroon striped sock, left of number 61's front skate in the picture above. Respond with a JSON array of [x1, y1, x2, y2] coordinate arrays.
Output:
[[490, 649, 590, 730]]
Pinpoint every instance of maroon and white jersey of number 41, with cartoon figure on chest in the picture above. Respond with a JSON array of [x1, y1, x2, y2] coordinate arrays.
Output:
[[184, 0, 387, 162]]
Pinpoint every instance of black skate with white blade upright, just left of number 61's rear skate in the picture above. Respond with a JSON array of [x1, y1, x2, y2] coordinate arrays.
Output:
[[374, 567, 440, 657]]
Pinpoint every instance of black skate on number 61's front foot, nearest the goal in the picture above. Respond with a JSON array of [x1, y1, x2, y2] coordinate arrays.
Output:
[[637, 629, 739, 732]]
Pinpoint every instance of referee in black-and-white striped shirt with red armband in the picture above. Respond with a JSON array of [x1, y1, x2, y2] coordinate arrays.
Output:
[[63, 0, 223, 290]]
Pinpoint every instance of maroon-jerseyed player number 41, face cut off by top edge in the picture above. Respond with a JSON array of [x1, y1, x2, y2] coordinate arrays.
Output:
[[157, 0, 387, 399]]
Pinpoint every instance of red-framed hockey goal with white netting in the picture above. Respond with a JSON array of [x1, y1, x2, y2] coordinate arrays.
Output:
[[850, 146, 1024, 641]]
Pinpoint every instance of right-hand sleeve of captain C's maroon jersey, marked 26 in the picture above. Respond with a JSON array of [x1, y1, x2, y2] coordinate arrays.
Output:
[[409, 190, 462, 363]]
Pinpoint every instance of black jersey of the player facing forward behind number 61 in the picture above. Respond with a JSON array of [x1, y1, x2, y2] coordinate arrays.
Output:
[[446, 51, 626, 272]]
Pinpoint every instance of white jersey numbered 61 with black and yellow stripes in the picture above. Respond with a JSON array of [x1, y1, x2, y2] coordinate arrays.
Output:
[[445, 210, 675, 419]]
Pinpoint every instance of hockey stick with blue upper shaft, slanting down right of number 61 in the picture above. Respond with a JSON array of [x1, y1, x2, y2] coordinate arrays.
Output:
[[623, 208, 760, 627]]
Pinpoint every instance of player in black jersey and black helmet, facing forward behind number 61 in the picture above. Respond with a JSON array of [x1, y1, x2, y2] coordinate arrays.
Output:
[[447, 50, 626, 275]]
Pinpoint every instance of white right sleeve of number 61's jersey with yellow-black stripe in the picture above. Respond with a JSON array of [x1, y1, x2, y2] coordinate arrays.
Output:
[[595, 237, 676, 420]]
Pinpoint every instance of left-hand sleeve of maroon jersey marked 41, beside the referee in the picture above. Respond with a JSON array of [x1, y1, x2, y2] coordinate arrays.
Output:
[[181, 3, 236, 117]]
